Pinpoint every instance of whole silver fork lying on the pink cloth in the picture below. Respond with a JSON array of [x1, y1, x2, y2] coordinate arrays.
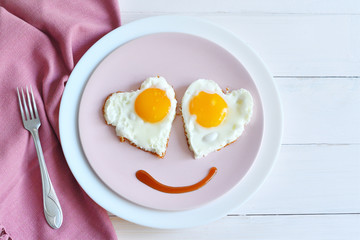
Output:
[[17, 86, 63, 229]]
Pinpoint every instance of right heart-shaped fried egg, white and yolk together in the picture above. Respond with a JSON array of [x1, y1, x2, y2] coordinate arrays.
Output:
[[181, 79, 254, 159]]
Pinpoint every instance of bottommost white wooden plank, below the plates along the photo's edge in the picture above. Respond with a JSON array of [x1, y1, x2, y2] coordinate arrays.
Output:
[[111, 215, 360, 240]]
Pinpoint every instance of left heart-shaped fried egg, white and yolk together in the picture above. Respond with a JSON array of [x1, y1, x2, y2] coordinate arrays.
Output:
[[103, 76, 177, 157]]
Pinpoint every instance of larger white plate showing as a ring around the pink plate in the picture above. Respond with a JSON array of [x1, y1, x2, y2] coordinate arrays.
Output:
[[59, 16, 282, 228]]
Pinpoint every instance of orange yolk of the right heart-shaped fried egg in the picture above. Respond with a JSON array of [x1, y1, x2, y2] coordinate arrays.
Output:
[[189, 91, 228, 128]]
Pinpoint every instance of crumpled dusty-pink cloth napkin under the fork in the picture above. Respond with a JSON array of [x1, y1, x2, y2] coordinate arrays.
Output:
[[0, 0, 120, 240]]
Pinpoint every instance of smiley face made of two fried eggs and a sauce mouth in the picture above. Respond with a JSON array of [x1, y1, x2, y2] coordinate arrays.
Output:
[[103, 76, 252, 194]]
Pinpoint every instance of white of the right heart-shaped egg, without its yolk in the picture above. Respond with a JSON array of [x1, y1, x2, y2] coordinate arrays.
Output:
[[181, 79, 254, 159]]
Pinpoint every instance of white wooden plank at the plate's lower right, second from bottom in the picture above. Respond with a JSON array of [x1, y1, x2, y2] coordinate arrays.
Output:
[[233, 145, 360, 215]]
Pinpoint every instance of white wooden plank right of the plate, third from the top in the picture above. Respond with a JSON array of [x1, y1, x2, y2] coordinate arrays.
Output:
[[275, 78, 360, 144]]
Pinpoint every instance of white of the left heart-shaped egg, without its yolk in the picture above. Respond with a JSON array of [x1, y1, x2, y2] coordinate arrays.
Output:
[[104, 77, 177, 157]]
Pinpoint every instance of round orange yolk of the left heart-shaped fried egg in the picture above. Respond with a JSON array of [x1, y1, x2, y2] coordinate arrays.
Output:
[[135, 88, 171, 123]]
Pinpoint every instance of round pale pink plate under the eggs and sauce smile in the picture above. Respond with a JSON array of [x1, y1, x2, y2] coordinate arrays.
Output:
[[79, 33, 264, 210]]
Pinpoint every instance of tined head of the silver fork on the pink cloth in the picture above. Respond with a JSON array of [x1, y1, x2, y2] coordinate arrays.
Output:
[[16, 86, 39, 122]]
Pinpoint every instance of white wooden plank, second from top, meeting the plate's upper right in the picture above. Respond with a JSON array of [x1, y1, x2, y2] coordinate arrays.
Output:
[[122, 14, 360, 76]]
